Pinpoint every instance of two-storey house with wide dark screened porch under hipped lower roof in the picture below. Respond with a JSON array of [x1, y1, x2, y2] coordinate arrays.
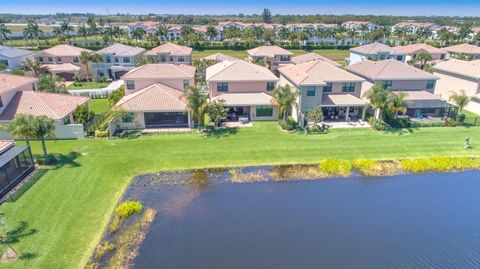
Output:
[[116, 64, 196, 130]]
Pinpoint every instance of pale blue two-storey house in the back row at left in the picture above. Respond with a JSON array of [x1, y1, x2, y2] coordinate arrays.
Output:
[[92, 43, 145, 79]]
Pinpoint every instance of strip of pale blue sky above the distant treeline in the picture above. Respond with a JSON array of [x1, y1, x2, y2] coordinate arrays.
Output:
[[0, 0, 480, 16]]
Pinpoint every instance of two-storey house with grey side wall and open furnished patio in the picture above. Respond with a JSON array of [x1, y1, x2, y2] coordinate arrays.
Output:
[[279, 61, 369, 127]]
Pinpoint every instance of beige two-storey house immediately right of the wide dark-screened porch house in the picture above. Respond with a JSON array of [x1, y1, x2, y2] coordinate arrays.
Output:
[[206, 60, 278, 121]]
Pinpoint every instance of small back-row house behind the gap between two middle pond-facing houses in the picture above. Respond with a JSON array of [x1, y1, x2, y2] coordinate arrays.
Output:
[[247, 46, 293, 70]]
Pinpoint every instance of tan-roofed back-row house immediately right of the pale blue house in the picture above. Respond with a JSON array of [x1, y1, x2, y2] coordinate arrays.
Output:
[[145, 42, 192, 64]]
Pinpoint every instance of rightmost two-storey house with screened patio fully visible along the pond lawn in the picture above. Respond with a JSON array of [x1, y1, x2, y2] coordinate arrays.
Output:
[[347, 59, 449, 118]]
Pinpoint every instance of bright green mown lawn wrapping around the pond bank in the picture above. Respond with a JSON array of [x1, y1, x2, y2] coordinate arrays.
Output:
[[0, 122, 480, 268]]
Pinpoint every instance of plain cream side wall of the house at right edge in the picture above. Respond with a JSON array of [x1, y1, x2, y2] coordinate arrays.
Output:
[[434, 71, 480, 99]]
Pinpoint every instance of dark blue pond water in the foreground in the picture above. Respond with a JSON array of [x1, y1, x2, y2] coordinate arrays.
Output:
[[126, 171, 480, 269]]
